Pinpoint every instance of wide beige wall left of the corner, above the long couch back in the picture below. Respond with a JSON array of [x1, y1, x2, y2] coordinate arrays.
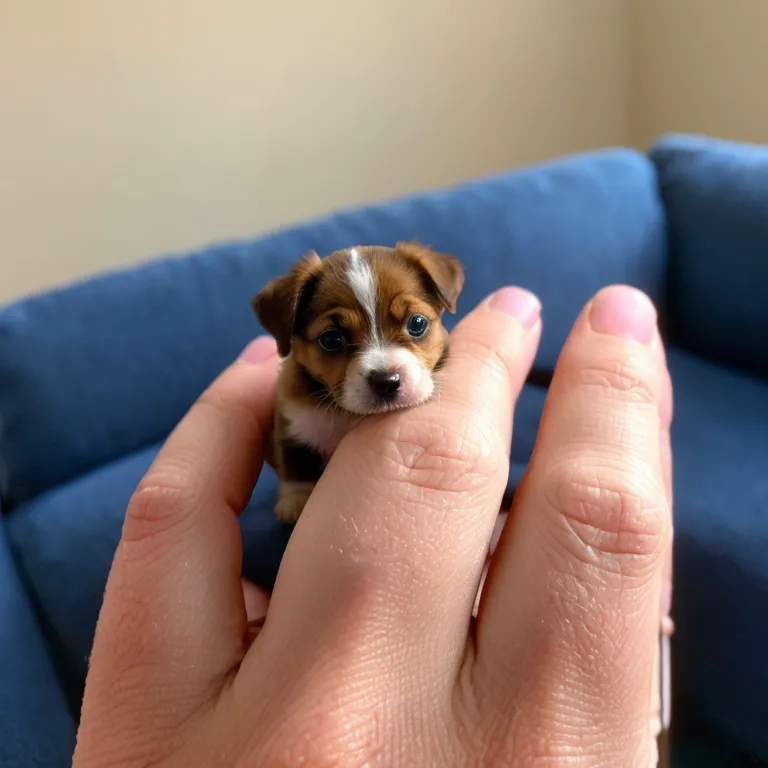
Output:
[[0, 0, 632, 301]]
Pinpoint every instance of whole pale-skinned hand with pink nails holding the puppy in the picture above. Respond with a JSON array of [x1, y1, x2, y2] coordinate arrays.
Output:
[[74, 286, 672, 768]]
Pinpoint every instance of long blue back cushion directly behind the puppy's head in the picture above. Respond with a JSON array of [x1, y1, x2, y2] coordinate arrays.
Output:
[[0, 150, 665, 507]]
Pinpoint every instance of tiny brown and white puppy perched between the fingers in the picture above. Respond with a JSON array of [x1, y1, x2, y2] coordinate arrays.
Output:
[[253, 243, 464, 523]]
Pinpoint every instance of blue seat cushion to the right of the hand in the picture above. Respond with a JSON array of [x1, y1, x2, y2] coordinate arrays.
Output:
[[669, 349, 768, 761]]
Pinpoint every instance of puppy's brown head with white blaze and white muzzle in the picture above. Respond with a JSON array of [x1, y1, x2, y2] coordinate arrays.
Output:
[[253, 243, 464, 414]]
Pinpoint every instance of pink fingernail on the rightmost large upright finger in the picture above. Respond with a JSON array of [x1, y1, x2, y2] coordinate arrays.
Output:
[[589, 285, 656, 344]]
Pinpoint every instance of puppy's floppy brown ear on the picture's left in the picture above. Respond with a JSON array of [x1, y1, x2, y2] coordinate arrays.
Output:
[[251, 251, 322, 357]]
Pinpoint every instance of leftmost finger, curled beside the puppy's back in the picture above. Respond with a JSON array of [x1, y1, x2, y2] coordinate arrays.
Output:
[[80, 340, 276, 736]]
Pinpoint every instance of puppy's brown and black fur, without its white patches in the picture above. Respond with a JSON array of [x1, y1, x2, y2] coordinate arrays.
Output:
[[253, 243, 464, 522]]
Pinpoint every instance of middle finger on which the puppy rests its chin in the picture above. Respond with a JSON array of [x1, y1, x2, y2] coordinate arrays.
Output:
[[246, 289, 541, 680]]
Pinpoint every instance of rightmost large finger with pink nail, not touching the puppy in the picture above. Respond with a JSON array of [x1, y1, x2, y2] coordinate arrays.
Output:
[[476, 287, 670, 765]]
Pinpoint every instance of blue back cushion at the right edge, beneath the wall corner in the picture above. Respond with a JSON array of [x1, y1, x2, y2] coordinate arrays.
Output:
[[651, 136, 768, 376]]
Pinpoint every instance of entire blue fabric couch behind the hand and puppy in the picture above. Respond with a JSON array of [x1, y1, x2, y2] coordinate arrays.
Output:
[[0, 136, 768, 766]]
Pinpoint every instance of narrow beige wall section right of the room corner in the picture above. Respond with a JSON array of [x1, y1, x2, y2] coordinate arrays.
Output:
[[633, 0, 768, 146]]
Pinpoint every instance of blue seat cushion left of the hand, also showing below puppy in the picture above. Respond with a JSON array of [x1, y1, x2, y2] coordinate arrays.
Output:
[[6, 438, 289, 702]]
